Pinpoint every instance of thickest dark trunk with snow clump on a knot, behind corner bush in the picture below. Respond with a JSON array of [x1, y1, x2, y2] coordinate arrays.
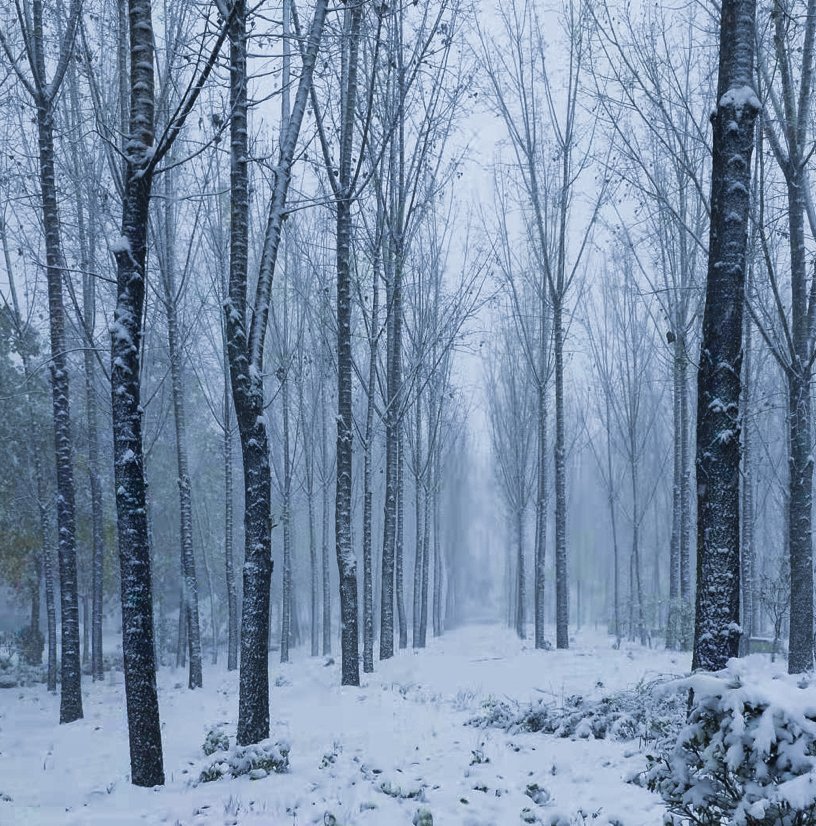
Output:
[[692, 0, 759, 670]]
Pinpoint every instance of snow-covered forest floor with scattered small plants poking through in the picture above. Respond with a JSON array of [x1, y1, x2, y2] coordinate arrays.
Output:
[[0, 625, 689, 826]]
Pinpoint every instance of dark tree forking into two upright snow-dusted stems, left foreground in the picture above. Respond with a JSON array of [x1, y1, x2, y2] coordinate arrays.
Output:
[[224, 0, 327, 745]]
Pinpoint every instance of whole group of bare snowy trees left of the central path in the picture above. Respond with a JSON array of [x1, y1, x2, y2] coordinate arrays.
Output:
[[0, 0, 484, 785]]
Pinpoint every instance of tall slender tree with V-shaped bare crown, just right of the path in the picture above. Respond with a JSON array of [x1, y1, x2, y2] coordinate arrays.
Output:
[[480, 0, 604, 648]]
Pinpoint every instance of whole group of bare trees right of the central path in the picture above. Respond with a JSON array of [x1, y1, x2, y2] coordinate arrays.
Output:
[[479, 0, 816, 672]]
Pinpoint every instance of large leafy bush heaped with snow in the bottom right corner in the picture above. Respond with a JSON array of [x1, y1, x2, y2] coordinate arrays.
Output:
[[645, 658, 816, 826]]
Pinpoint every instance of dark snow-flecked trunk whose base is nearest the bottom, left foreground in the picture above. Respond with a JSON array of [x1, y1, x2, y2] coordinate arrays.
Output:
[[110, 0, 164, 786]]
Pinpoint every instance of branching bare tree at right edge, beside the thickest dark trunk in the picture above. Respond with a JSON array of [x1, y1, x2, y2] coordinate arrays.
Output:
[[753, 0, 816, 674]]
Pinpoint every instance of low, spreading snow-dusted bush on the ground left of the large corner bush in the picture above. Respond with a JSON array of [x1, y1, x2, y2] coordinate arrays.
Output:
[[469, 680, 685, 740]]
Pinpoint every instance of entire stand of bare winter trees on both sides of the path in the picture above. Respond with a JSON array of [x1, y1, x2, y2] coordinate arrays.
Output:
[[0, 0, 816, 785]]
